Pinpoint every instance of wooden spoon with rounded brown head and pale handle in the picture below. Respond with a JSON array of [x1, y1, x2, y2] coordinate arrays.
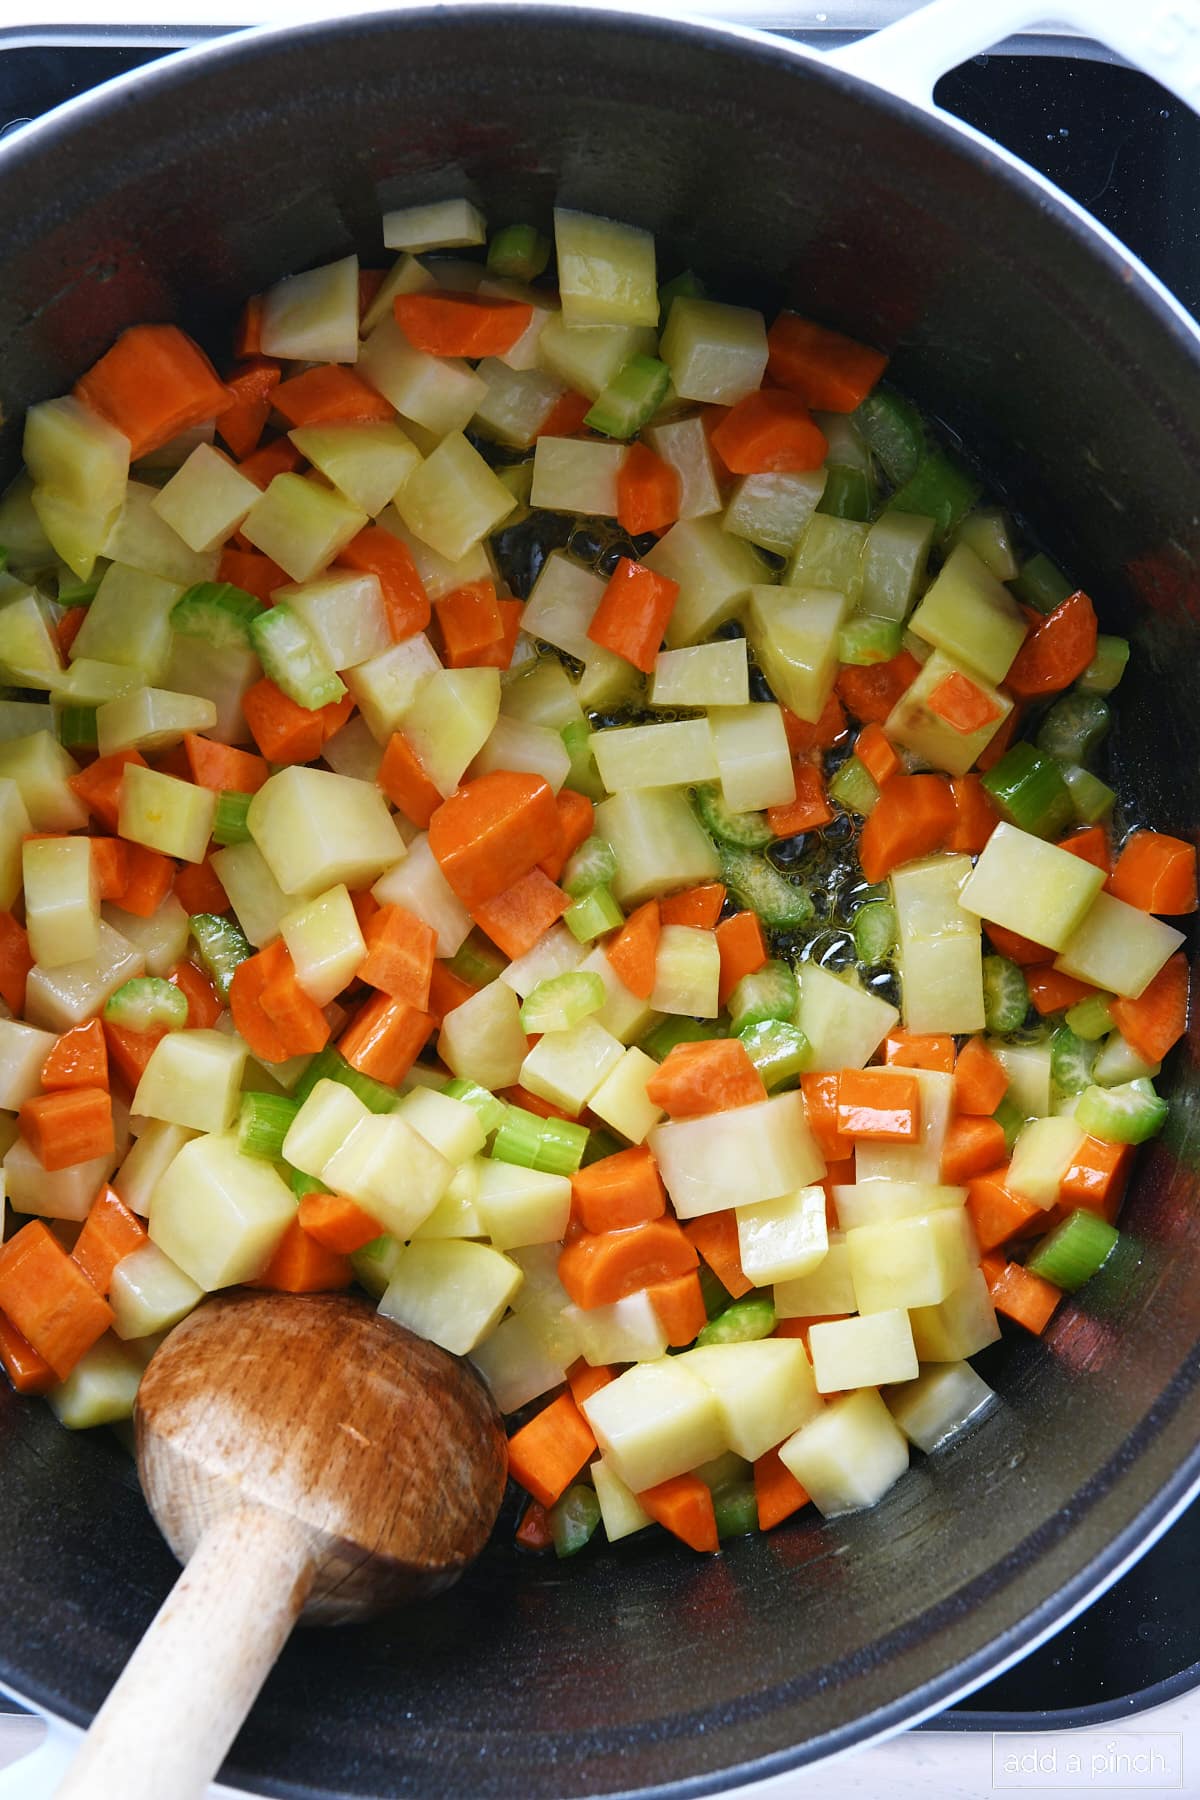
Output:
[[59, 1294, 507, 1800]]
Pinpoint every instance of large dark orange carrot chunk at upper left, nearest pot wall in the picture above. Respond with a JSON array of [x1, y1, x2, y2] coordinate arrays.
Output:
[[76, 326, 234, 463]]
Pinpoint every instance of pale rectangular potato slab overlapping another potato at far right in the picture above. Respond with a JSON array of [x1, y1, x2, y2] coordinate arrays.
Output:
[[959, 824, 1108, 950]]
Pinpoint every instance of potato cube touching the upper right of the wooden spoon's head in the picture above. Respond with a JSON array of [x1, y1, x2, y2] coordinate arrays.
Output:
[[380, 1238, 522, 1355]]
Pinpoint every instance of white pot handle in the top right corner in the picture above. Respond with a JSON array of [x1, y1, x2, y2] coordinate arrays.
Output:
[[826, 0, 1200, 112]]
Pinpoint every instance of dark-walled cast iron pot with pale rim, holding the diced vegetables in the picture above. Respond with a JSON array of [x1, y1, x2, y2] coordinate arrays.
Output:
[[0, 5, 1200, 1800]]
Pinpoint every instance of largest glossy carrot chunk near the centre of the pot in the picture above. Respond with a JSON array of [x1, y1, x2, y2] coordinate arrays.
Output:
[[430, 769, 558, 913]]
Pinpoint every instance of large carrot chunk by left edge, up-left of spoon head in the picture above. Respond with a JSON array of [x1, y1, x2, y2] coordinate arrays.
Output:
[[0, 1219, 113, 1381]]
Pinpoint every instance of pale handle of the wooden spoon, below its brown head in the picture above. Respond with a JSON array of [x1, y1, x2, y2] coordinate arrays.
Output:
[[58, 1507, 315, 1800]]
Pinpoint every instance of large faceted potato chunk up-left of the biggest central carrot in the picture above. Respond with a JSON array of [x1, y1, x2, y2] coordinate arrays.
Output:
[[248, 767, 405, 895]]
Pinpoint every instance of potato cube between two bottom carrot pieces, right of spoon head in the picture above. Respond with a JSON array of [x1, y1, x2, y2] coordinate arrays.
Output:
[[583, 1357, 729, 1494]]
